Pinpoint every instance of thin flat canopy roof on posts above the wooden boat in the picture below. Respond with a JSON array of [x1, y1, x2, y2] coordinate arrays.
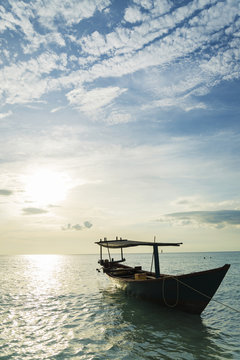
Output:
[[96, 239, 182, 249]]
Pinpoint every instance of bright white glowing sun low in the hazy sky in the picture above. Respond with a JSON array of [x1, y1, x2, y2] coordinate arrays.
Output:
[[25, 169, 71, 205]]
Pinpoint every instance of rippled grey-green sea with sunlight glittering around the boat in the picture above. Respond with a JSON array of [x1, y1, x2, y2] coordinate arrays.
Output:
[[0, 252, 240, 360]]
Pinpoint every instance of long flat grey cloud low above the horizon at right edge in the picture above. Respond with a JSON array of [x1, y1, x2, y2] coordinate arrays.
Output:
[[159, 210, 240, 229]]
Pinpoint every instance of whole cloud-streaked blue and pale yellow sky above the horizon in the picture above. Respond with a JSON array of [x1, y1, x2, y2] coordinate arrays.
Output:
[[0, 0, 240, 254]]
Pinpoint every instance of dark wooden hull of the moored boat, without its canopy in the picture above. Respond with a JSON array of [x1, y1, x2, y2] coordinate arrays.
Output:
[[108, 264, 230, 314]]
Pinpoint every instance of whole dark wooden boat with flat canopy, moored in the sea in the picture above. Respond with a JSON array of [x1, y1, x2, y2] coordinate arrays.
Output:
[[96, 238, 230, 315]]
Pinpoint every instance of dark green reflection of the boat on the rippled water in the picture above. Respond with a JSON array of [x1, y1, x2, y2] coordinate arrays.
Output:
[[98, 287, 226, 359]]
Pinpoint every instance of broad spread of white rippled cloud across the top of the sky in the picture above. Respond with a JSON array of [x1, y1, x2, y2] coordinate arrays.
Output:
[[0, 0, 240, 118]]
